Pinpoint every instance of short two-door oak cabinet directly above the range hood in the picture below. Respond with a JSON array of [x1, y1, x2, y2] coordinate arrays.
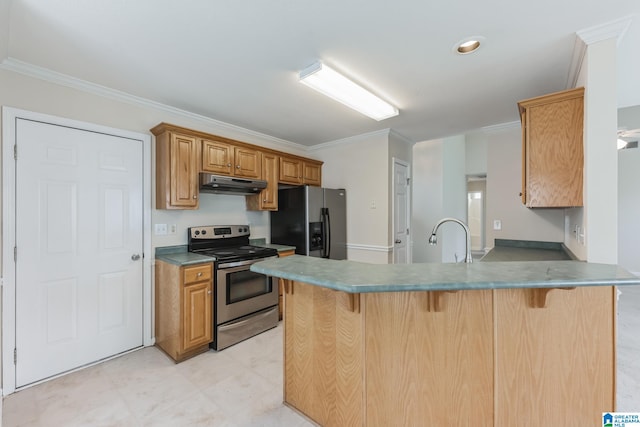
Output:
[[202, 139, 262, 179]]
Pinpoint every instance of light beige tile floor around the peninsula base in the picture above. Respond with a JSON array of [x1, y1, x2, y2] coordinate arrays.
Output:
[[2, 286, 640, 427]]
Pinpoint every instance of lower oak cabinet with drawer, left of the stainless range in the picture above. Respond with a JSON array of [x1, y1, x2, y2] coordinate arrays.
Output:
[[156, 261, 213, 362]]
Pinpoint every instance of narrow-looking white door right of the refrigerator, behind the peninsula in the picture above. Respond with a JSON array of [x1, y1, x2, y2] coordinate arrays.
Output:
[[393, 159, 410, 264]]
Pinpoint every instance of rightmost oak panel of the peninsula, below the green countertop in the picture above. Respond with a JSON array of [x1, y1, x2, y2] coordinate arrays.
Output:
[[495, 286, 615, 427]]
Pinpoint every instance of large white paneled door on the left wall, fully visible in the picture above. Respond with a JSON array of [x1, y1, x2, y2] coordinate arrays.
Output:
[[15, 118, 144, 387]]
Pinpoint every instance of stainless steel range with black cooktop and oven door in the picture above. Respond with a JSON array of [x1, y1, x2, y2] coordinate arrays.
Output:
[[188, 225, 278, 350]]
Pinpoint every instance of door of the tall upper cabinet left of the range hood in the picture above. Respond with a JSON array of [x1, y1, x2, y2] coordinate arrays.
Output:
[[169, 134, 198, 208]]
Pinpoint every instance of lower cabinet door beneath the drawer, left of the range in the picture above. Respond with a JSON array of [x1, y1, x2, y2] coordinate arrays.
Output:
[[182, 281, 213, 351]]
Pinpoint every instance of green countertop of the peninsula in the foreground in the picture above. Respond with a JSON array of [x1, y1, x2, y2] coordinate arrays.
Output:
[[251, 255, 640, 293]]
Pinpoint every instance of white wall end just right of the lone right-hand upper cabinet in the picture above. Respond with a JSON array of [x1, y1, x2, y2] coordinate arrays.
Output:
[[564, 38, 618, 264]]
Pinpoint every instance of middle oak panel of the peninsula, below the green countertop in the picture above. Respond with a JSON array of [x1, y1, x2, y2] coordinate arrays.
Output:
[[364, 290, 494, 427]]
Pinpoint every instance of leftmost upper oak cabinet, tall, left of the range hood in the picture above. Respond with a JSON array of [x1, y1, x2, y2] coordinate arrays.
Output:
[[151, 126, 200, 209]]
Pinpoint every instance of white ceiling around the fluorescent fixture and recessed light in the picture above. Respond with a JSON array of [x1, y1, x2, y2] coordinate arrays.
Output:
[[0, 0, 640, 146]]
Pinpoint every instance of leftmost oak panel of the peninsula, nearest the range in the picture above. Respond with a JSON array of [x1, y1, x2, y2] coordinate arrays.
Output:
[[284, 282, 363, 427]]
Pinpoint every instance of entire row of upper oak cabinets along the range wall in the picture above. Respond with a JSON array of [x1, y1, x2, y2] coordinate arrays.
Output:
[[151, 123, 322, 210]]
